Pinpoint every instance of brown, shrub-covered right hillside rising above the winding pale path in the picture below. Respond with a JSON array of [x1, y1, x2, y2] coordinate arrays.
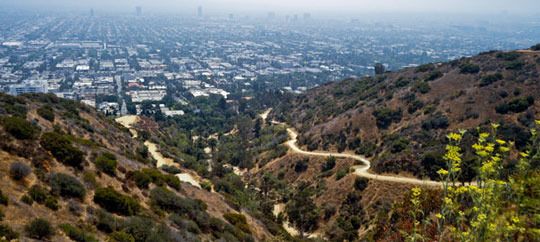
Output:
[[270, 50, 540, 180]]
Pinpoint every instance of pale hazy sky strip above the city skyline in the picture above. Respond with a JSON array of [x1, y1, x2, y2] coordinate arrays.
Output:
[[4, 0, 540, 14]]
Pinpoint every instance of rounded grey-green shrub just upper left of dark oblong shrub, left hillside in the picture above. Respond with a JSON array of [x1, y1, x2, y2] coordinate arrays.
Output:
[[49, 173, 86, 199]]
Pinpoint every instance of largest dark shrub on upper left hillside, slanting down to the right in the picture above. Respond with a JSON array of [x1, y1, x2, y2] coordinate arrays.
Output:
[[40, 132, 84, 167]]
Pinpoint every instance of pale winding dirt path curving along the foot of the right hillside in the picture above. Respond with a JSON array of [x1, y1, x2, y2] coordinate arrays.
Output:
[[287, 128, 448, 186]]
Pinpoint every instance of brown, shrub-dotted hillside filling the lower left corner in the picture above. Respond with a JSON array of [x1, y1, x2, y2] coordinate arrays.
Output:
[[0, 94, 270, 241]]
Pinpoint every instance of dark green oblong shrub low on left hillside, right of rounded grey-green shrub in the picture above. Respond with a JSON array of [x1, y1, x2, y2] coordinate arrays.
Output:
[[94, 187, 141, 216]]
